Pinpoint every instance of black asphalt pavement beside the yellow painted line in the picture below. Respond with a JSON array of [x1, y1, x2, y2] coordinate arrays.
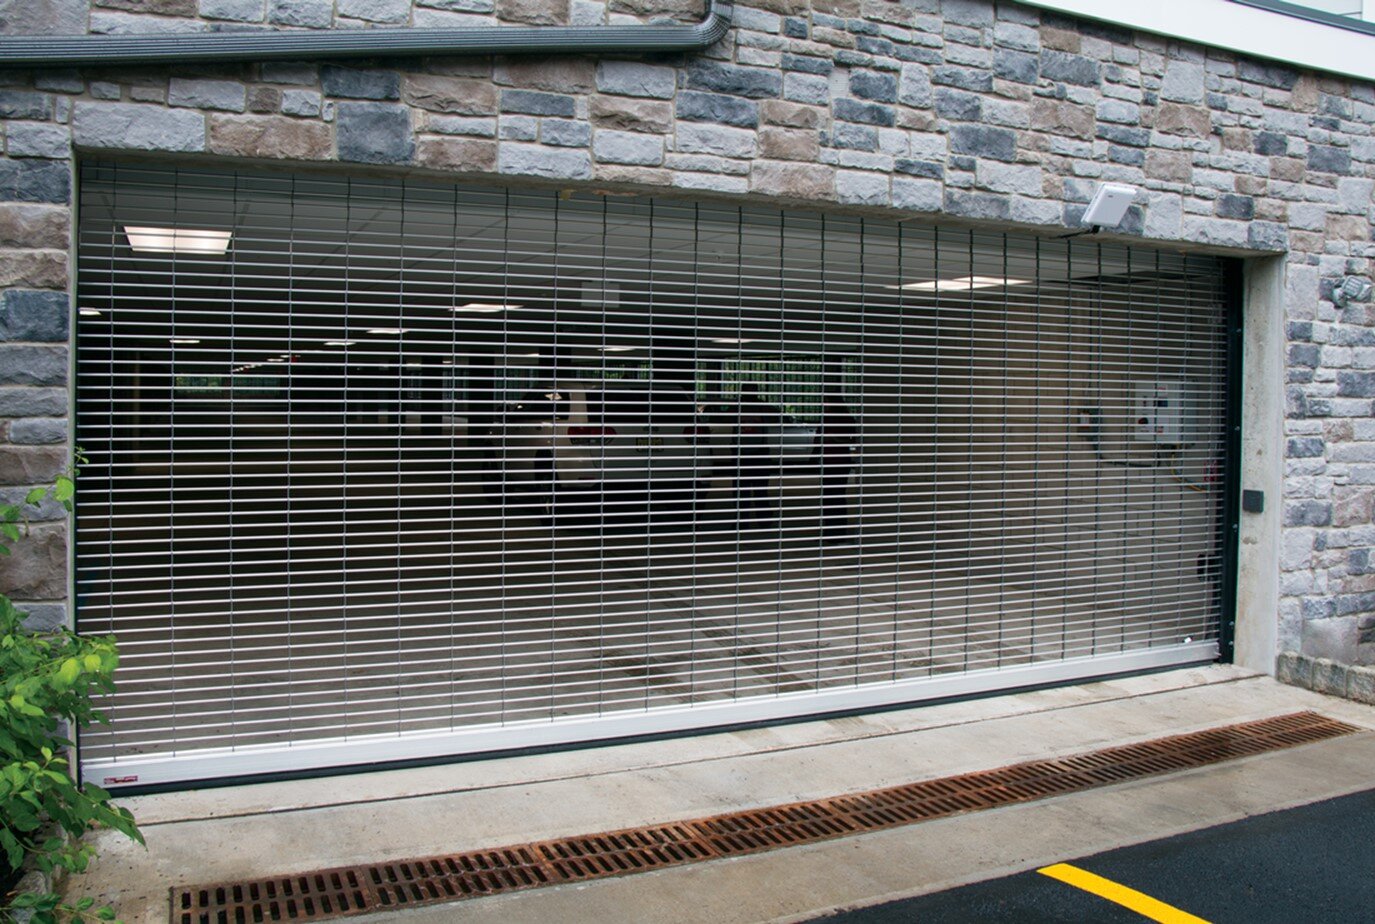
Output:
[[815, 789, 1375, 924]]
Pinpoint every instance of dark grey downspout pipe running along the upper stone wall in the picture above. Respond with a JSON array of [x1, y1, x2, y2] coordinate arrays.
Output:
[[0, 0, 730, 67]]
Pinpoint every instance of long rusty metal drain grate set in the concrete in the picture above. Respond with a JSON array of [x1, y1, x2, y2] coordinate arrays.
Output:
[[172, 712, 1361, 924]]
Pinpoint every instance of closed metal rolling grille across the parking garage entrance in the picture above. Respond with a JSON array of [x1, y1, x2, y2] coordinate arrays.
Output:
[[77, 164, 1227, 784]]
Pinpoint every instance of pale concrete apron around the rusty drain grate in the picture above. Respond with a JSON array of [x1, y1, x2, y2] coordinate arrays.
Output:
[[69, 667, 1375, 923]]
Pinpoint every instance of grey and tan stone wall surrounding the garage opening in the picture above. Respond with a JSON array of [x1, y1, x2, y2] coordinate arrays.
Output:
[[0, 0, 1375, 690]]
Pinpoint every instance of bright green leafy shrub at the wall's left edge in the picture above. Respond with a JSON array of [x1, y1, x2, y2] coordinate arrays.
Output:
[[0, 464, 143, 924]]
